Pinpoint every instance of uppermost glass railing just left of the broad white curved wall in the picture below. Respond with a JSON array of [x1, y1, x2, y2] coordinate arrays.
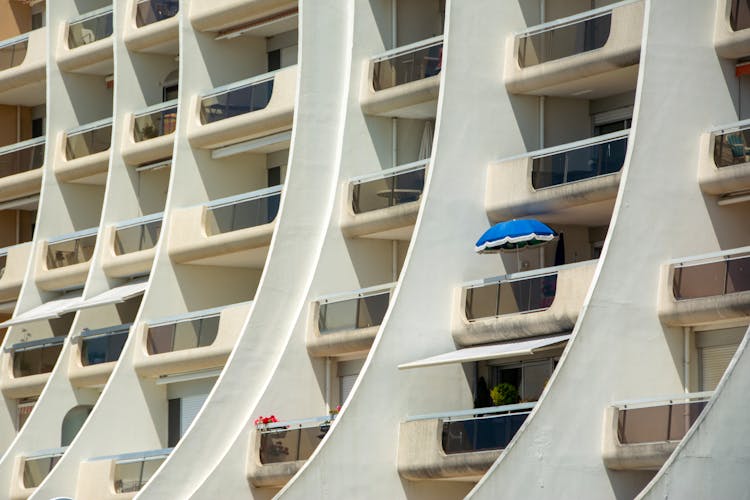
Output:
[[201, 73, 274, 125]]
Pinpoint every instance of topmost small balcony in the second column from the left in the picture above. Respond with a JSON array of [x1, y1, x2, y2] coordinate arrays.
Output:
[[57, 5, 114, 76]]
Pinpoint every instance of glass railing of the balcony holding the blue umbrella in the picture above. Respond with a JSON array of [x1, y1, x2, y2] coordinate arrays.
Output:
[[464, 267, 557, 321]]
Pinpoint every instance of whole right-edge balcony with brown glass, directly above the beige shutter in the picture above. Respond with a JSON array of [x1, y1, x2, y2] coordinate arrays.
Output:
[[659, 247, 750, 326]]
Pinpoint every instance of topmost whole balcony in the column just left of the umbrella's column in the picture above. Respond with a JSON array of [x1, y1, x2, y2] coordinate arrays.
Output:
[[360, 35, 443, 119]]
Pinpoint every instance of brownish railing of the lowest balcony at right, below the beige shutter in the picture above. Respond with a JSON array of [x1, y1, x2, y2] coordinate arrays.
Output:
[[613, 392, 713, 444]]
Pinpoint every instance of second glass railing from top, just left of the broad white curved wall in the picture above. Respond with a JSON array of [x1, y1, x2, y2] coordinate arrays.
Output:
[[206, 186, 282, 235]]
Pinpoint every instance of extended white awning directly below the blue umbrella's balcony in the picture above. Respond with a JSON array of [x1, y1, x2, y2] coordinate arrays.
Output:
[[398, 334, 570, 370]]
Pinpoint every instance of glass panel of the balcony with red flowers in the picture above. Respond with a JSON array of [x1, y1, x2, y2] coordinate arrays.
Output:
[[260, 422, 331, 464]]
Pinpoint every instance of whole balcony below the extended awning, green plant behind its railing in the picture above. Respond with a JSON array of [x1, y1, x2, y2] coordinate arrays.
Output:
[[398, 403, 535, 481]]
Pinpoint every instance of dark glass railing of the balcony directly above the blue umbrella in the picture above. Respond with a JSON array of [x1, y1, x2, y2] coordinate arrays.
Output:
[[531, 130, 630, 189]]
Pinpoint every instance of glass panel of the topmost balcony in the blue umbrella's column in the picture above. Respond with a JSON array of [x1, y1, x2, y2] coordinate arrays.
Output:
[[518, 12, 612, 68]]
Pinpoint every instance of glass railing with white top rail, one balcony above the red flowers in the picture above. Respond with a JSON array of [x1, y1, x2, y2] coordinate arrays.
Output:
[[318, 283, 396, 334]]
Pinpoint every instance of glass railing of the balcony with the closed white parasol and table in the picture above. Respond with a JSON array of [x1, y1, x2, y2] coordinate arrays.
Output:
[[351, 159, 430, 214]]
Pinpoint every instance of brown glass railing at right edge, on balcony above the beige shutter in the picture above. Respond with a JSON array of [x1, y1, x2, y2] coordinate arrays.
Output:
[[672, 251, 750, 300]]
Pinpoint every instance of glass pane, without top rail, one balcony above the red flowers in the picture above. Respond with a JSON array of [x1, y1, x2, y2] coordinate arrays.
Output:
[[318, 291, 391, 333]]
